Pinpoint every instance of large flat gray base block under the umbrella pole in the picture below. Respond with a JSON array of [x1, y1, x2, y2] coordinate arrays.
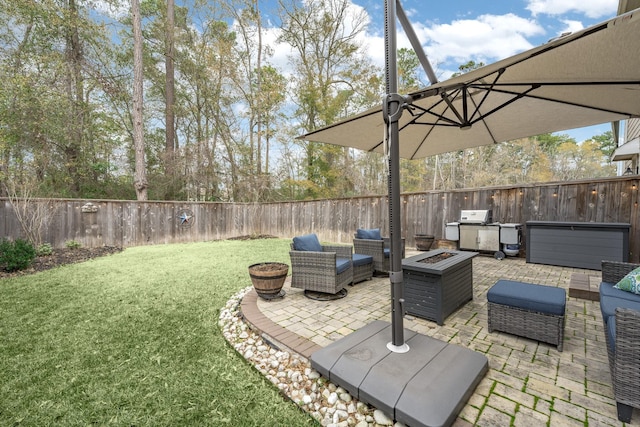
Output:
[[311, 320, 489, 427]]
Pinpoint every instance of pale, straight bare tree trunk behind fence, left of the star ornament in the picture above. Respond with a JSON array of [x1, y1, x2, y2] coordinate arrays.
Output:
[[131, 0, 147, 200]]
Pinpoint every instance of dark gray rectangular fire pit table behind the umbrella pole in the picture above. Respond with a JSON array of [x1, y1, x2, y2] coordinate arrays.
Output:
[[402, 249, 478, 325]]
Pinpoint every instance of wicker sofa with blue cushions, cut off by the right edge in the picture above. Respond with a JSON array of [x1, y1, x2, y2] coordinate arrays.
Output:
[[600, 261, 640, 423]]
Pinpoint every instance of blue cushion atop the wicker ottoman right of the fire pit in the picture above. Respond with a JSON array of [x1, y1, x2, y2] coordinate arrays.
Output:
[[487, 280, 567, 316]]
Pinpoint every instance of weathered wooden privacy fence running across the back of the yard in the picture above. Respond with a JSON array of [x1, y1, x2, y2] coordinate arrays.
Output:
[[0, 176, 640, 262]]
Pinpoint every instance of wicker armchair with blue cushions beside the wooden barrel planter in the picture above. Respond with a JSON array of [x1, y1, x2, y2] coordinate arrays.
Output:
[[289, 235, 353, 294]]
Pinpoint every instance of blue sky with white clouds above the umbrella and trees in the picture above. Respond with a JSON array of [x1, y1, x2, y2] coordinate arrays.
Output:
[[258, 0, 618, 142]]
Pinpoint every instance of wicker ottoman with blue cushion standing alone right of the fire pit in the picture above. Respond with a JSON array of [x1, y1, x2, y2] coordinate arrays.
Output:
[[487, 280, 567, 351]]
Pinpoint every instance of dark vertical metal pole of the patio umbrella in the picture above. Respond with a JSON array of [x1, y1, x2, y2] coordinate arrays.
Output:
[[382, 0, 409, 353]]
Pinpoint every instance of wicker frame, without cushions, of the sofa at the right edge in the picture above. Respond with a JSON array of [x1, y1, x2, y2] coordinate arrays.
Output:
[[602, 261, 640, 423]]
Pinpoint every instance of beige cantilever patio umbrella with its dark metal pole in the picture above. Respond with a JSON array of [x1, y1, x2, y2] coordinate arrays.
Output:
[[301, 0, 640, 352]]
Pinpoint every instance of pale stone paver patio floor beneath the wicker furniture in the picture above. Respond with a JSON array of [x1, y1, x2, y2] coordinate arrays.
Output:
[[242, 251, 640, 426]]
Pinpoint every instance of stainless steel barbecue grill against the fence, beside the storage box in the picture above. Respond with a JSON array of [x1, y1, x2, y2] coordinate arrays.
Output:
[[445, 209, 521, 259]]
